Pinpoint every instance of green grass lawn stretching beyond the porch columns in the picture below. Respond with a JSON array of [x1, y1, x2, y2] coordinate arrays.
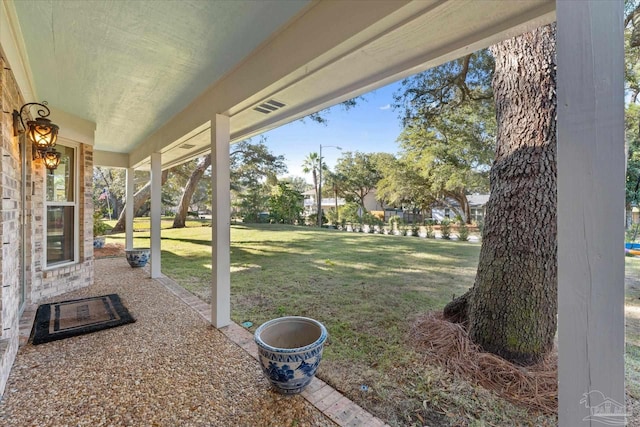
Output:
[[108, 220, 640, 426]]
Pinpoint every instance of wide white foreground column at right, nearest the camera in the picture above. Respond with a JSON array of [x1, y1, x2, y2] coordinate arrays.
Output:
[[556, 0, 625, 427]]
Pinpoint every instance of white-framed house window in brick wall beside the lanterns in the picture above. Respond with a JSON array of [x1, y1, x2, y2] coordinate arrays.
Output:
[[45, 145, 78, 267]]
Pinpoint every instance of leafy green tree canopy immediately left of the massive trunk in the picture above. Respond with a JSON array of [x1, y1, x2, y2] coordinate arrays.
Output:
[[383, 50, 496, 222]]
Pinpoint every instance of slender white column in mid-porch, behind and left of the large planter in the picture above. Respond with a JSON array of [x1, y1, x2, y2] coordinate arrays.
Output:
[[211, 114, 231, 328]]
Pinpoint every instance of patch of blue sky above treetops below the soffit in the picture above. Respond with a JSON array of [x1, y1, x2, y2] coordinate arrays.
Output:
[[263, 82, 402, 182]]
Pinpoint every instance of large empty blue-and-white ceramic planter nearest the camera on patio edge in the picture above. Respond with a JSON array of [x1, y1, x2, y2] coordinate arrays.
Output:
[[255, 316, 327, 394]]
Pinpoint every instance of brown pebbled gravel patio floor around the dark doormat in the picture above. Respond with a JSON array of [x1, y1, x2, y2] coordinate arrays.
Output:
[[0, 257, 335, 427]]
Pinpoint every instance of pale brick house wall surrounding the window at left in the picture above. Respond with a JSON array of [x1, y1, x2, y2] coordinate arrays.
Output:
[[0, 55, 93, 395]]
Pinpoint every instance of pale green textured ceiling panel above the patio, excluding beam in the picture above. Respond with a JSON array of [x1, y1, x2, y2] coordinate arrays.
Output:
[[15, 0, 309, 152]]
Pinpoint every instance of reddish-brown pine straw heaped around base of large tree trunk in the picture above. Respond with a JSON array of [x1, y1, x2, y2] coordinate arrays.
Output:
[[409, 313, 558, 415]]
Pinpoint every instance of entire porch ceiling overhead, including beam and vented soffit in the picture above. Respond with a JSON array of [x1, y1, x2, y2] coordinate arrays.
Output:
[[0, 0, 555, 168]]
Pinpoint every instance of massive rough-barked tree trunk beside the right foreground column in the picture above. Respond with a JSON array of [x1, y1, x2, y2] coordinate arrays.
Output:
[[445, 26, 557, 365]]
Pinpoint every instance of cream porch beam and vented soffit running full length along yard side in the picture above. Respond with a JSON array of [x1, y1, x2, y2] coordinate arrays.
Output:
[[139, 0, 555, 171]]
